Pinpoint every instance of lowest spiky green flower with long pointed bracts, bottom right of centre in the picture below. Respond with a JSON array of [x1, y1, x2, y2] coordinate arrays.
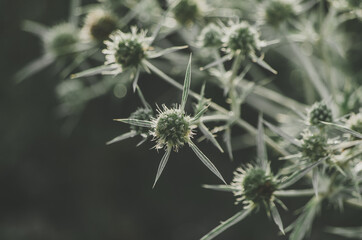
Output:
[[201, 117, 326, 240]]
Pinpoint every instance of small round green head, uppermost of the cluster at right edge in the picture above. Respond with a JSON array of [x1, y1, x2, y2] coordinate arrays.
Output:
[[309, 102, 333, 126]]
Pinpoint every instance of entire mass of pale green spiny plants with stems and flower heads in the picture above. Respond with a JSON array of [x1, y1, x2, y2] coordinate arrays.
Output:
[[15, 0, 362, 240]]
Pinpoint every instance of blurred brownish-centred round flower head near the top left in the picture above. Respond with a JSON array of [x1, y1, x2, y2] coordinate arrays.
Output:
[[82, 8, 118, 42]]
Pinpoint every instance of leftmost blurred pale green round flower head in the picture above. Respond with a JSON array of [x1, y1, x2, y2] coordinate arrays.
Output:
[[44, 23, 79, 56]]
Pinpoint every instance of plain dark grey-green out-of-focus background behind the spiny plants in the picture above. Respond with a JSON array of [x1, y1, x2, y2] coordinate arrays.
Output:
[[0, 0, 362, 240]]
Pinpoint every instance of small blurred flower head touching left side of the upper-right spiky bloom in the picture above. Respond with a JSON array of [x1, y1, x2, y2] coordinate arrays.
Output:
[[199, 23, 223, 48]]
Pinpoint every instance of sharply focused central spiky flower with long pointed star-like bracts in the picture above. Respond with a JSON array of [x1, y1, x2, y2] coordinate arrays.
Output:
[[116, 56, 225, 187]]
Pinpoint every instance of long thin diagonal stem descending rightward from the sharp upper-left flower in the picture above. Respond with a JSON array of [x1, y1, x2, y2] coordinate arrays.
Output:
[[144, 58, 290, 156]]
